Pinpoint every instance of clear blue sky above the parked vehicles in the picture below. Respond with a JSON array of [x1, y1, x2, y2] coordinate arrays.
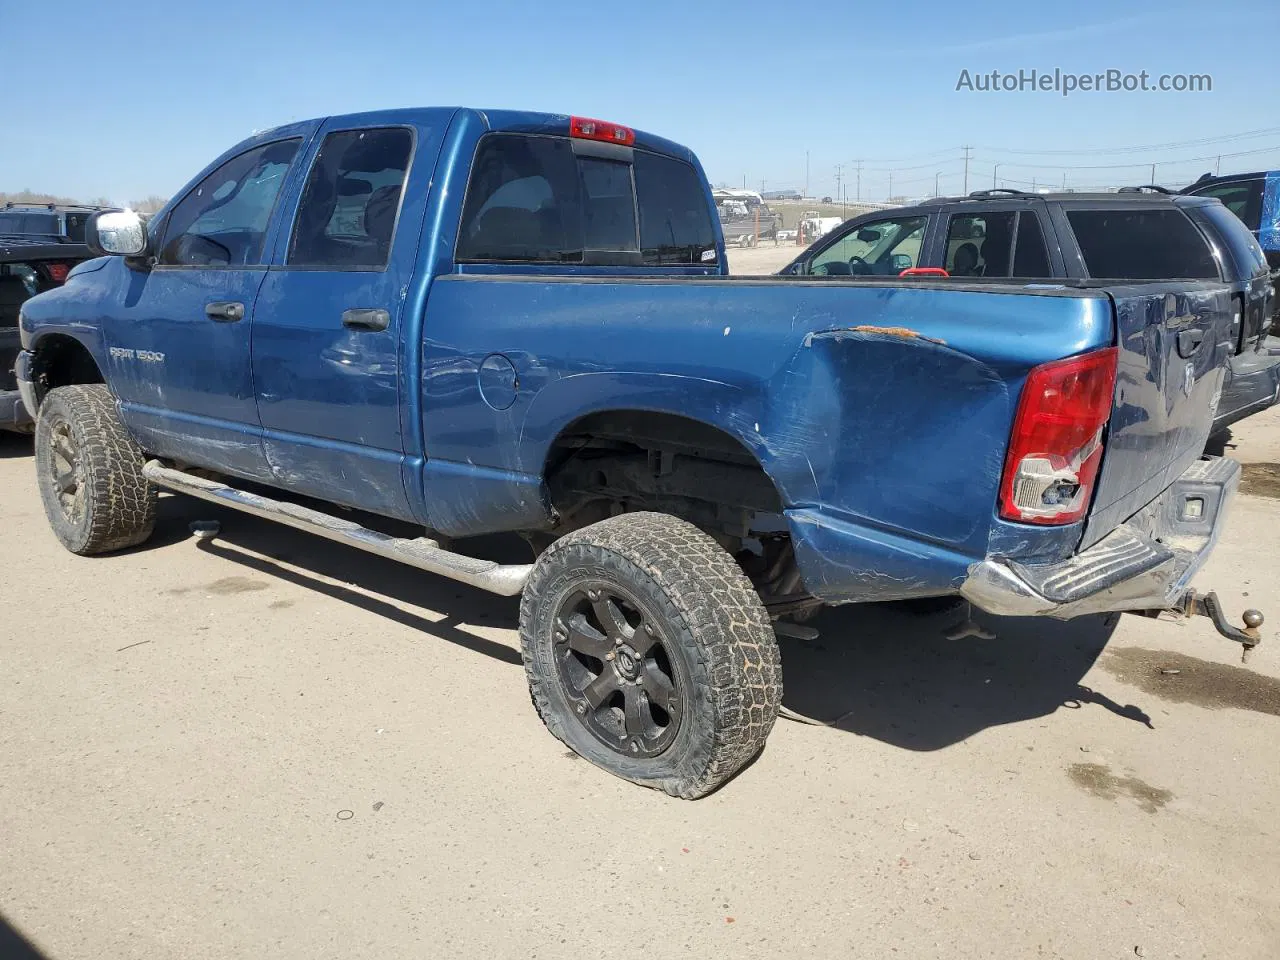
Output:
[[0, 0, 1280, 201]]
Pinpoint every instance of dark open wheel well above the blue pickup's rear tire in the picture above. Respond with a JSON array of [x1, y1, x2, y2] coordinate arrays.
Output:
[[535, 411, 805, 607]]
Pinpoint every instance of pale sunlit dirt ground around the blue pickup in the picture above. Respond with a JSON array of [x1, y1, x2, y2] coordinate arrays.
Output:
[[0, 401, 1280, 960]]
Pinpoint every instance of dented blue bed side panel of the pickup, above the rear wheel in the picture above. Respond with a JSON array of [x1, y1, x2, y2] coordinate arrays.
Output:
[[424, 275, 1112, 581]]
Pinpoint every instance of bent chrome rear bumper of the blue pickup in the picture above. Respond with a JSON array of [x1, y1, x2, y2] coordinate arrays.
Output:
[[960, 457, 1240, 620]]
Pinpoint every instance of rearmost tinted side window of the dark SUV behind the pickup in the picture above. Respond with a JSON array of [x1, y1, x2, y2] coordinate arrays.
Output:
[[1066, 210, 1219, 280]]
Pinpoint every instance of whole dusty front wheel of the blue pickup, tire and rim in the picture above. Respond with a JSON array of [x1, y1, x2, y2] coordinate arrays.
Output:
[[36, 384, 156, 557]]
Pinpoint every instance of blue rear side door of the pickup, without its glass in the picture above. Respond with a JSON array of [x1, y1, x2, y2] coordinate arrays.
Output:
[[253, 114, 447, 520]]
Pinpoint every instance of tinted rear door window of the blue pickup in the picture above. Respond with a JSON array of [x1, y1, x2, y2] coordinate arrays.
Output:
[[287, 127, 413, 270]]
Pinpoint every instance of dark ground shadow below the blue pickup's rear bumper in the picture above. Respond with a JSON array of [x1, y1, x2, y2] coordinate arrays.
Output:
[[781, 604, 1152, 750]]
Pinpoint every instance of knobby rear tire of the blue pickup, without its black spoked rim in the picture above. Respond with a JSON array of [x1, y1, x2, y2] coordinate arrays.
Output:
[[520, 512, 782, 799]]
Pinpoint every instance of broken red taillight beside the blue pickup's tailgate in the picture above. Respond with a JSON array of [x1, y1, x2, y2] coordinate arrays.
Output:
[[1000, 347, 1119, 524]]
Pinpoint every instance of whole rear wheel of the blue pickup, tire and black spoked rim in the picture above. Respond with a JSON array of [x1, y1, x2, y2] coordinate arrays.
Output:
[[520, 513, 782, 800]]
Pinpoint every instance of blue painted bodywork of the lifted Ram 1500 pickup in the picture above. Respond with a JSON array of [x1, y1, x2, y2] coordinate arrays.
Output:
[[10, 108, 1224, 609]]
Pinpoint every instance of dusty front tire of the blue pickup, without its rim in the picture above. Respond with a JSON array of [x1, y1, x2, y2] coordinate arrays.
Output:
[[36, 384, 157, 556]]
